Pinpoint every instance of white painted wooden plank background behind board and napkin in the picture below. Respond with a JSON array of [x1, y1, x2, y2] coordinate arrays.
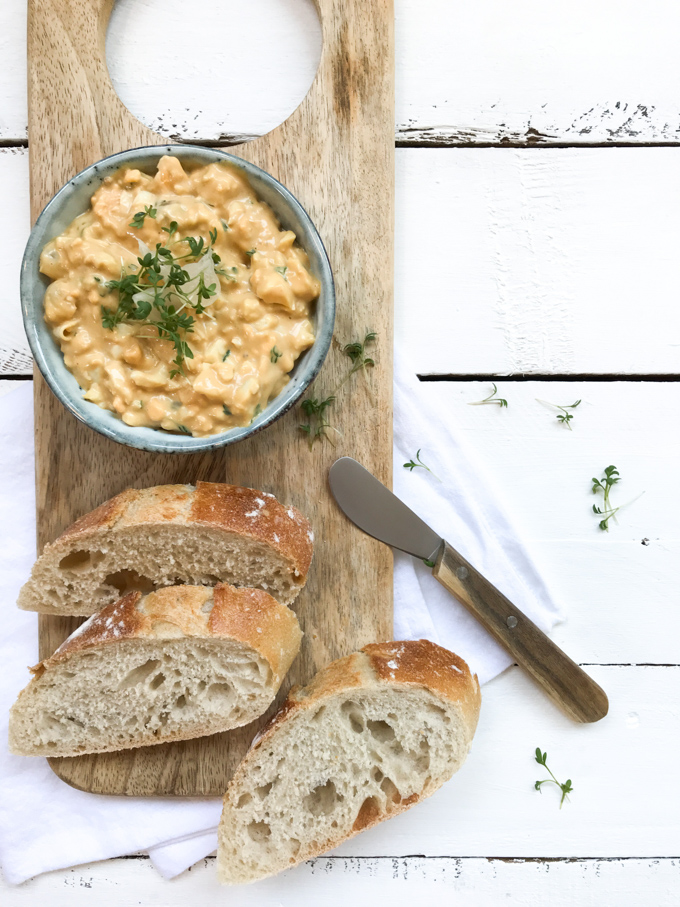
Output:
[[0, 0, 680, 907]]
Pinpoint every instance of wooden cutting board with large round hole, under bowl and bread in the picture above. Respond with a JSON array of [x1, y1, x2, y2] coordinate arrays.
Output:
[[28, 0, 394, 796]]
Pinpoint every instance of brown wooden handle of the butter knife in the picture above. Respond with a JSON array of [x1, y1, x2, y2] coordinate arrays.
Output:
[[433, 542, 609, 722]]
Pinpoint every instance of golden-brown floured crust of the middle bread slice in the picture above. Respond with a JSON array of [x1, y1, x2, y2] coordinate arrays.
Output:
[[30, 583, 302, 686]]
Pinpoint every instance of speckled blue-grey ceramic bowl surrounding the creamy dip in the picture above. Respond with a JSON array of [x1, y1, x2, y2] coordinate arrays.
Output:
[[21, 145, 335, 453]]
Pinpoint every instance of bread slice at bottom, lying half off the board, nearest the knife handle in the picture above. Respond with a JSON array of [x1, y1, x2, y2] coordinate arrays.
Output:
[[217, 640, 481, 884]]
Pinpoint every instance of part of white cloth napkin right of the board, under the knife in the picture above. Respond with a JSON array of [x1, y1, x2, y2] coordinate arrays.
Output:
[[393, 366, 564, 683]]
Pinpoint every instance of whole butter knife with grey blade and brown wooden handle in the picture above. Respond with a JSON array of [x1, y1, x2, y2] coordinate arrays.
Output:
[[328, 457, 609, 723]]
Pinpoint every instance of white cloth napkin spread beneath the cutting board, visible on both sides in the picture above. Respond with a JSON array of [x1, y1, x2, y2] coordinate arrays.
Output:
[[0, 376, 560, 884]]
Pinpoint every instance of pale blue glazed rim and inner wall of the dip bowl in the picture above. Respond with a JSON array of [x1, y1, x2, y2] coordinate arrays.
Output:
[[20, 144, 335, 453]]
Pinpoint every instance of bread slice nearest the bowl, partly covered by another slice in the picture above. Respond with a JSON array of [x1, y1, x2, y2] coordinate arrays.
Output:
[[18, 482, 314, 616]]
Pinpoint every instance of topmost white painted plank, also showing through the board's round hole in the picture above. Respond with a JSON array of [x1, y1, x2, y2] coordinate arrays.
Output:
[[0, 0, 680, 144]]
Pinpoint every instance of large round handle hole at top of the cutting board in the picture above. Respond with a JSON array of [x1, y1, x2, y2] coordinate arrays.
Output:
[[106, 0, 322, 144]]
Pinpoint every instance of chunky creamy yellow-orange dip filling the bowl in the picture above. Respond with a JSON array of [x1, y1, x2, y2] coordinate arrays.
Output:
[[40, 157, 320, 437]]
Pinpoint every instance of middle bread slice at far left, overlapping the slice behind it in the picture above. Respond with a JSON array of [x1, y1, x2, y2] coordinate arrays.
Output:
[[9, 585, 302, 756]]
